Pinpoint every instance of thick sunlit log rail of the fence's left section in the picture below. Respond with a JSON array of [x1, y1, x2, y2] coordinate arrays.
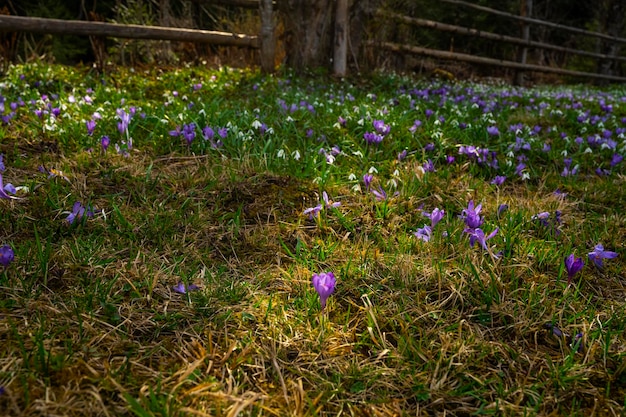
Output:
[[0, 15, 259, 48]]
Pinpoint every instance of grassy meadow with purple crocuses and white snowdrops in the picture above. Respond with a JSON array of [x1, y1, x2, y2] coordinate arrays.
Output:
[[0, 64, 626, 416]]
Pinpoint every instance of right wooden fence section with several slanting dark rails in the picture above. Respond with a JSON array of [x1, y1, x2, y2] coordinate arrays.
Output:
[[370, 0, 626, 82]]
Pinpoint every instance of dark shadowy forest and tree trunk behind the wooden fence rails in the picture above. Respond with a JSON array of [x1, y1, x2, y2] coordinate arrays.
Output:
[[0, 0, 626, 79]]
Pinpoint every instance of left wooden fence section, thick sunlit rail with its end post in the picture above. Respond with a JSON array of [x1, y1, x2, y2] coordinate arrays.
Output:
[[0, 0, 276, 72]]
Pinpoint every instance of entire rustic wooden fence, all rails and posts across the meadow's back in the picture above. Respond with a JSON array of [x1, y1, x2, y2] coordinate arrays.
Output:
[[0, 0, 626, 82]]
